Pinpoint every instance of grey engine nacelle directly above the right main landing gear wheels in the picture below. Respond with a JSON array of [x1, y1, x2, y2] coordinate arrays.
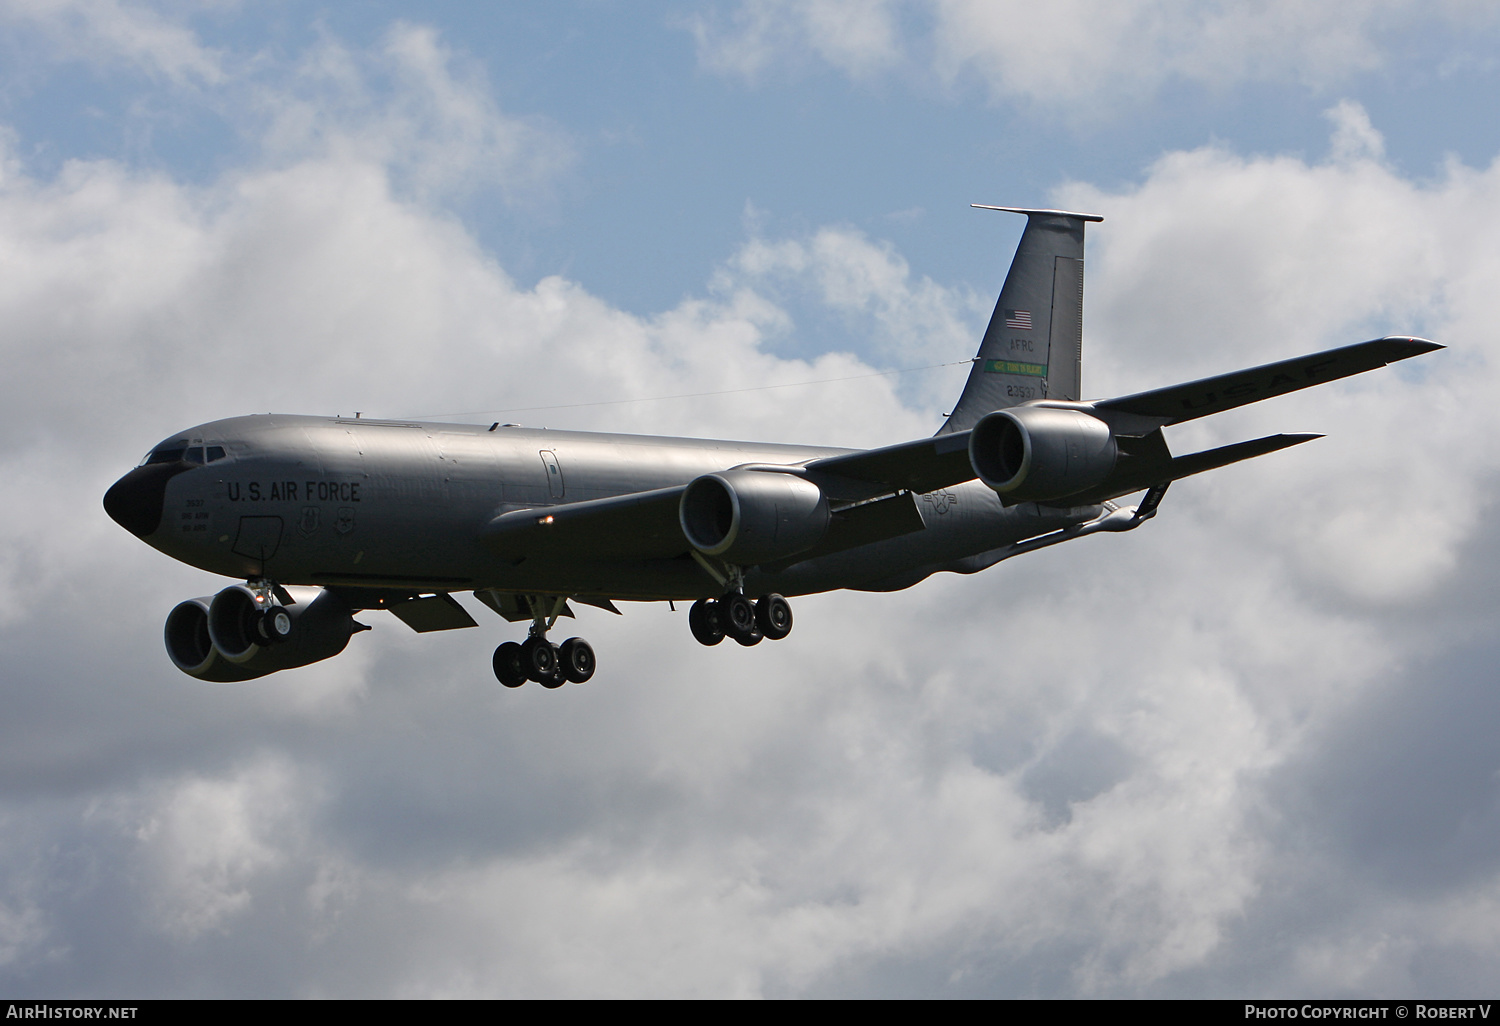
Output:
[[678, 470, 830, 566]]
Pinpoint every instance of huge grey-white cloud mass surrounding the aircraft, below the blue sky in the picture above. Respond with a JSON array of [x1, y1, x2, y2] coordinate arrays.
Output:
[[0, 22, 1500, 996]]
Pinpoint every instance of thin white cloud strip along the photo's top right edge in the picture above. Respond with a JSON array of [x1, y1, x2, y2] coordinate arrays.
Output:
[[695, 0, 1496, 111]]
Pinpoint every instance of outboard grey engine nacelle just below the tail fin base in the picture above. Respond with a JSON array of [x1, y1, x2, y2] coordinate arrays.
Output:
[[969, 407, 1118, 504]]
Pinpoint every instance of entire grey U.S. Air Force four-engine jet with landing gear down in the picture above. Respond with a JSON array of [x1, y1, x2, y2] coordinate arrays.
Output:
[[104, 204, 1443, 687]]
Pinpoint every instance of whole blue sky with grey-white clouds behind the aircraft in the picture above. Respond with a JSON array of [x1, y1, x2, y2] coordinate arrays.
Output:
[[0, 0, 1500, 998]]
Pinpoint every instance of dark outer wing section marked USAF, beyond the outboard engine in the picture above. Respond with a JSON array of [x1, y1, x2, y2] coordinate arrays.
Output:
[[1091, 336, 1445, 434]]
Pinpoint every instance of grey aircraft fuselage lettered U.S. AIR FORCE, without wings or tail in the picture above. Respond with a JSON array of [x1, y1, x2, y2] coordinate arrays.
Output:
[[120, 416, 1100, 600]]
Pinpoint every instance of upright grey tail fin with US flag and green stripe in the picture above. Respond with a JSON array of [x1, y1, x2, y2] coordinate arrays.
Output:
[[938, 203, 1104, 435]]
